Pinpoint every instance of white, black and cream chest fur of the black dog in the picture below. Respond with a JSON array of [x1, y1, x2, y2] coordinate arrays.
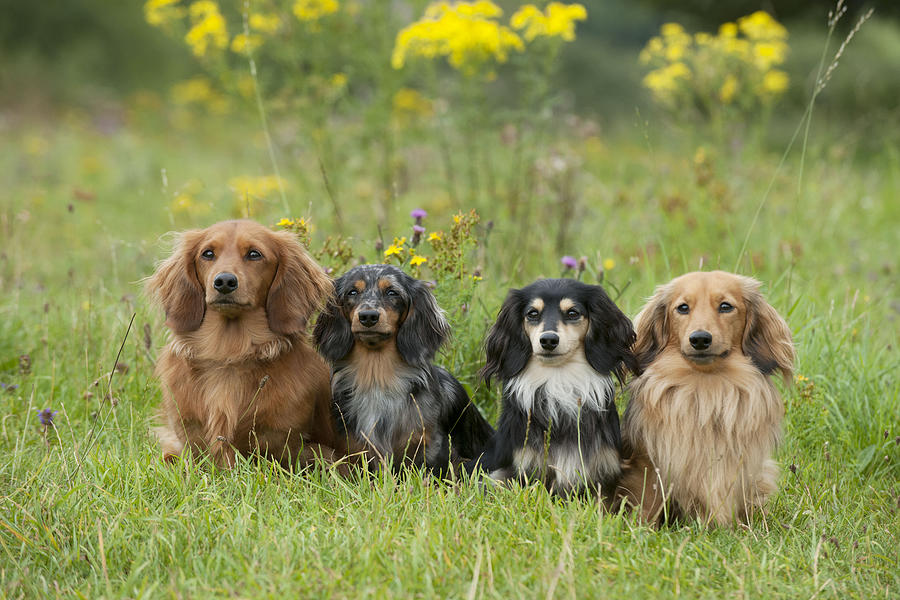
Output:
[[506, 358, 620, 493]]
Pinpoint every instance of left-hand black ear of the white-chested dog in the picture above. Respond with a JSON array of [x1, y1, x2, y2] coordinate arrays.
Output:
[[480, 290, 531, 385]]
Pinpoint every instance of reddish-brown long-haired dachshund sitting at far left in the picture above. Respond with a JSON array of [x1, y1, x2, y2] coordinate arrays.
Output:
[[146, 220, 344, 468]]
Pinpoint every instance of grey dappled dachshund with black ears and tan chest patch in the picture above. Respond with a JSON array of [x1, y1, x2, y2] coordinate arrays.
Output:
[[313, 265, 493, 475]]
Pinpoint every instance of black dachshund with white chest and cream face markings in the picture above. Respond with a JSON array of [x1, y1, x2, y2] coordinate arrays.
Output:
[[474, 279, 636, 497]]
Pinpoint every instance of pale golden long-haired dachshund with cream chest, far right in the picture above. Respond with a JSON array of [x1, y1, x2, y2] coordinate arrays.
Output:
[[620, 271, 794, 525]]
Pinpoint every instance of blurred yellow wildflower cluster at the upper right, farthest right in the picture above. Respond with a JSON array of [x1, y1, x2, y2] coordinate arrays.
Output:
[[640, 11, 789, 116]]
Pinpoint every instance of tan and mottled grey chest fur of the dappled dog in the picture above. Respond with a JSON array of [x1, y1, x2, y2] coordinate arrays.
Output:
[[332, 349, 435, 458]]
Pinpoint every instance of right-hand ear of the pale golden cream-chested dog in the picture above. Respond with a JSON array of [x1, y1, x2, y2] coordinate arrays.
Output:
[[741, 277, 794, 383]]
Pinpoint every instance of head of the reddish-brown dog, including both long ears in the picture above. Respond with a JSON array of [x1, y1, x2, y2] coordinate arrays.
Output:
[[147, 221, 331, 335]]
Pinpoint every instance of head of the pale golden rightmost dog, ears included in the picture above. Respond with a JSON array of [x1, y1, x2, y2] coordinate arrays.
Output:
[[635, 271, 794, 379]]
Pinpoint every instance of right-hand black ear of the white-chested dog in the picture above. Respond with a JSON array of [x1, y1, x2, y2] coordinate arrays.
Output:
[[584, 285, 638, 381]]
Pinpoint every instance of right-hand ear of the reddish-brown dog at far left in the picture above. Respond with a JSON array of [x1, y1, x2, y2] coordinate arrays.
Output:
[[266, 231, 332, 335]]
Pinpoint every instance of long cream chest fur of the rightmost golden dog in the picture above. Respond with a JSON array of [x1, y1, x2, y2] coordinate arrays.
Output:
[[625, 357, 784, 521]]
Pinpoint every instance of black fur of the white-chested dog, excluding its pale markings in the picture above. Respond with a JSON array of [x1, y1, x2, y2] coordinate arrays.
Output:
[[467, 279, 637, 495]]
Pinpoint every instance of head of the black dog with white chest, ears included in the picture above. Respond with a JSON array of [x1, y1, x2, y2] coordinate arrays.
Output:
[[481, 279, 636, 382]]
